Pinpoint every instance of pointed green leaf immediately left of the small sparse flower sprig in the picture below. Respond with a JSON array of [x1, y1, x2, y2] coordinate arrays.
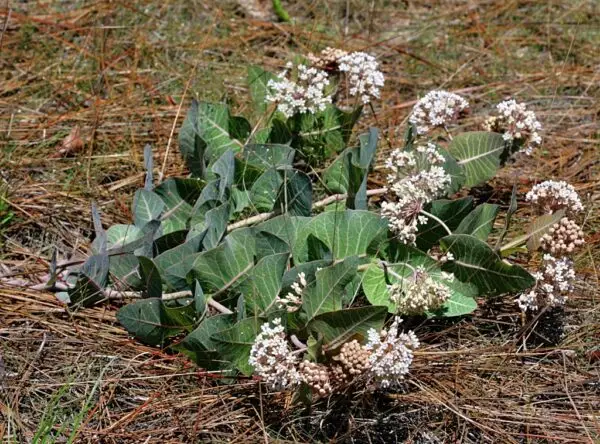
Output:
[[234, 253, 289, 315]]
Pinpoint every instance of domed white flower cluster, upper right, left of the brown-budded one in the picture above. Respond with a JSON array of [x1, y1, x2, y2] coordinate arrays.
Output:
[[408, 91, 469, 134]]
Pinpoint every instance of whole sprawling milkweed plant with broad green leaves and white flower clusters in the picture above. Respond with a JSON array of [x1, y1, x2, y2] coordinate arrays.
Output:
[[52, 48, 584, 399]]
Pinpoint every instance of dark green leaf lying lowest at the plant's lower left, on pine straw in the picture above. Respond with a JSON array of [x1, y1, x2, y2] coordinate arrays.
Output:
[[117, 299, 196, 346]]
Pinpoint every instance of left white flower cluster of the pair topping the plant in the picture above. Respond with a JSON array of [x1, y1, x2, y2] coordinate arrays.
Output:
[[266, 64, 331, 117]]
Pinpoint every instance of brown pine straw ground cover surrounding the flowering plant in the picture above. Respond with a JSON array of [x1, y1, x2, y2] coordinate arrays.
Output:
[[0, 0, 600, 443]]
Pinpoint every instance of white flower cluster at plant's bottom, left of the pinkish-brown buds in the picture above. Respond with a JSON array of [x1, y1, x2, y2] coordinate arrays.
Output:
[[248, 318, 300, 389]]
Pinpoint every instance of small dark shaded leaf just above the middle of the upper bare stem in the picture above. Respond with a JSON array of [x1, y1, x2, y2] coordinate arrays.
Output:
[[274, 170, 312, 216]]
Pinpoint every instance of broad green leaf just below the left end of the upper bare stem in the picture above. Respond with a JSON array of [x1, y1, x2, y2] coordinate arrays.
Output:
[[187, 228, 256, 293]]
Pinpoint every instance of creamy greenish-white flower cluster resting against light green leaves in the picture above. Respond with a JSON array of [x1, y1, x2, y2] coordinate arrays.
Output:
[[388, 266, 454, 315]]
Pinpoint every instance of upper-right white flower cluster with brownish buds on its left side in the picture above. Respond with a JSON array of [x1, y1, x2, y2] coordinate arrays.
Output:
[[484, 99, 542, 154]]
